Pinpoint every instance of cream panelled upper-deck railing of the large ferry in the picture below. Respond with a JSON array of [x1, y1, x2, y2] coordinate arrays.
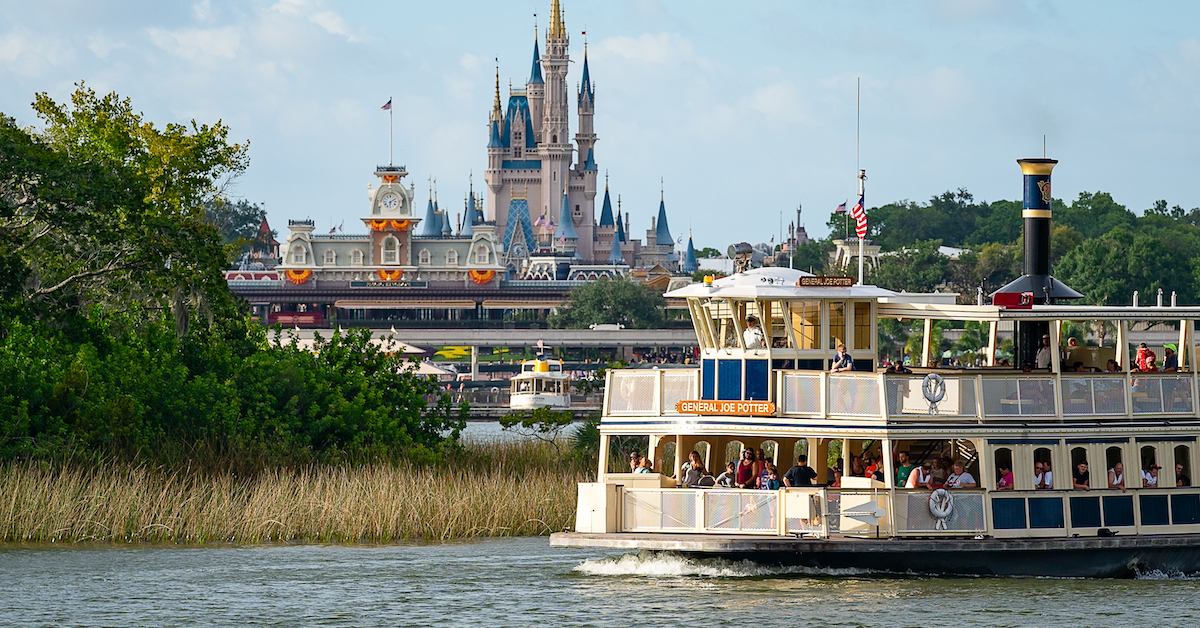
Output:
[[604, 369, 1198, 423]]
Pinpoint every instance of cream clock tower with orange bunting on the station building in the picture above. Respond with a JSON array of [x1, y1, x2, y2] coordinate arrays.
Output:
[[362, 166, 421, 267]]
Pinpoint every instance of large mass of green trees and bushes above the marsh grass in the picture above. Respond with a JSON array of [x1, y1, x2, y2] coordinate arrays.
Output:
[[0, 85, 462, 468]]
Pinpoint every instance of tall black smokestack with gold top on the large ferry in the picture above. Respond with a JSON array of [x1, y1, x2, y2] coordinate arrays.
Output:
[[991, 157, 1084, 367]]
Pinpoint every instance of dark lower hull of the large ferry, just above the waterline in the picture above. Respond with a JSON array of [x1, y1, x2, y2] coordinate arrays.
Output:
[[550, 532, 1200, 578]]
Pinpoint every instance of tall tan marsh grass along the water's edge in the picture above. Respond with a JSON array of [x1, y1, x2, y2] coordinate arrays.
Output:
[[0, 441, 594, 543]]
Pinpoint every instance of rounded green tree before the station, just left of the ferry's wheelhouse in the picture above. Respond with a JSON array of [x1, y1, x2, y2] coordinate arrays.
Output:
[[550, 277, 666, 329]]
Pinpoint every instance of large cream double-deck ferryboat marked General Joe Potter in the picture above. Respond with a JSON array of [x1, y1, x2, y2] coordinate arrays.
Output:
[[551, 159, 1200, 578]]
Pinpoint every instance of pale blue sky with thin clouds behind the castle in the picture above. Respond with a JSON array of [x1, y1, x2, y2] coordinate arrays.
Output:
[[0, 0, 1200, 250]]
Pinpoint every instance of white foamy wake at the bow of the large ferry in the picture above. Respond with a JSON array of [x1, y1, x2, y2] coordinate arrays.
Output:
[[575, 551, 882, 578]]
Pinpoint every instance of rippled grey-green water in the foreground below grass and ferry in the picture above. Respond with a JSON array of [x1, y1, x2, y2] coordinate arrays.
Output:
[[0, 538, 1200, 628]]
